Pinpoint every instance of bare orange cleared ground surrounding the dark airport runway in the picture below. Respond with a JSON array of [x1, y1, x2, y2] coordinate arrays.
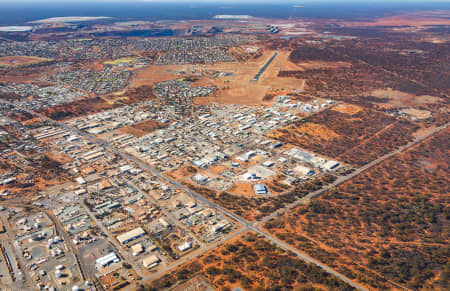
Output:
[[132, 50, 304, 105]]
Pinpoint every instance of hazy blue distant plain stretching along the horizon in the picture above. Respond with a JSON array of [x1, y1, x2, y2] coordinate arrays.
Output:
[[0, 0, 450, 25]]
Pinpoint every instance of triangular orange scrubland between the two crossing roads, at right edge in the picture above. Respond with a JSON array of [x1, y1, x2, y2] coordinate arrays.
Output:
[[265, 129, 450, 290]]
